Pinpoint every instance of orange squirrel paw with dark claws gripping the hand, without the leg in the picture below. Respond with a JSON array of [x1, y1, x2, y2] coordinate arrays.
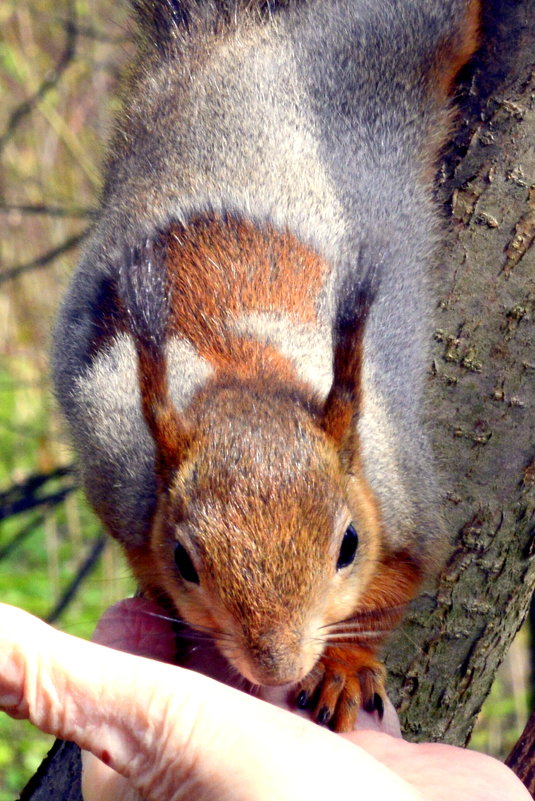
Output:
[[296, 647, 386, 732]]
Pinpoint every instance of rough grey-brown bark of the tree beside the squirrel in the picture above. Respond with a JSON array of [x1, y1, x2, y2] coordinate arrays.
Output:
[[18, 0, 535, 801]]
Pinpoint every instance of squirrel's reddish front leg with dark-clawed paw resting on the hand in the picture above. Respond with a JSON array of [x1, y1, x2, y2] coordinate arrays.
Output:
[[296, 552, 421, 732]]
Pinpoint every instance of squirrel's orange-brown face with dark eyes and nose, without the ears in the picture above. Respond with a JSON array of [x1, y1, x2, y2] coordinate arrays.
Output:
[[147, 383, 380, 684]]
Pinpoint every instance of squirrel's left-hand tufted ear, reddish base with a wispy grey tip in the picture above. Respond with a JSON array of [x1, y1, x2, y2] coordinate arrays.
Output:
[[118, 238, 191, 488]]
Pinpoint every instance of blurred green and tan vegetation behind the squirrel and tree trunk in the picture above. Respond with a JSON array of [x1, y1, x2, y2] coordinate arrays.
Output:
[[0, 0, 529, 801]]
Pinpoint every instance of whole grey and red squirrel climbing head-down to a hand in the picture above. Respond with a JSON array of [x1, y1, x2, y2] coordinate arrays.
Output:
[[53, 0, 480, 731]]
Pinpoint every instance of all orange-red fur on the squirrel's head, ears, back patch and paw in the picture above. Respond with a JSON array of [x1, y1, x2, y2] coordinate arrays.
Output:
[[93, 215, 420, 729]]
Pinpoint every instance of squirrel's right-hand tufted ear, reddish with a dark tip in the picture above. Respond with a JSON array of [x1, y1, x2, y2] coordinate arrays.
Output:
[[321, 270, 378, 450]]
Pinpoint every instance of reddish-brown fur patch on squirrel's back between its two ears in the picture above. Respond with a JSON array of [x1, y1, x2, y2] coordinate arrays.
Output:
[[167, 215, 327, 379]]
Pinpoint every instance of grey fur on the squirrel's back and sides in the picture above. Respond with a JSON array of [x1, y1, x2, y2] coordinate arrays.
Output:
[[54, 0, 466, 557]]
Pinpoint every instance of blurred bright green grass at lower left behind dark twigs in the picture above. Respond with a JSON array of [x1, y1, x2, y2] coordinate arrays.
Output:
[[0, 360, 133, 801]]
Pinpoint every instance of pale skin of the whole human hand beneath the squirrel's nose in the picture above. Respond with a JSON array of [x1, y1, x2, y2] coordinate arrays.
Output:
[[0, 599, 530, 801]]
